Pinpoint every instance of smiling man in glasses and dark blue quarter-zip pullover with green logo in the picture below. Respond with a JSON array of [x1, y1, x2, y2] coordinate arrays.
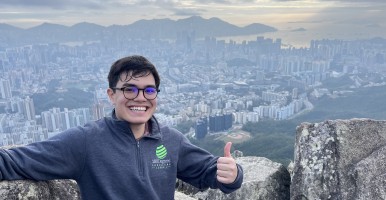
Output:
[[0, 56, 243, 200]]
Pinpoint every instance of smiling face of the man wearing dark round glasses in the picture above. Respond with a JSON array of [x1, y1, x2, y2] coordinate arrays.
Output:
[[107, 72, 157, 125]]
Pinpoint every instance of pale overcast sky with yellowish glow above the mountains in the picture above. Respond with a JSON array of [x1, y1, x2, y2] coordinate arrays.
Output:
[[0, 0, 386, 42]]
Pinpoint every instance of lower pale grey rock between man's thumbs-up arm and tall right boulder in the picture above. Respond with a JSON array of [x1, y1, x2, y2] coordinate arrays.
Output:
[[177, 157, 291, 200]]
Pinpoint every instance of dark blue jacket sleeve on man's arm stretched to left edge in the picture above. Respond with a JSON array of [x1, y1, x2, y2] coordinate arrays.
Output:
[[0, 128, 86, 180]]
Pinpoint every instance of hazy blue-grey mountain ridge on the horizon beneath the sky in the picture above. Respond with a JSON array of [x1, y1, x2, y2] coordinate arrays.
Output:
[[0, 16, 277, 47]]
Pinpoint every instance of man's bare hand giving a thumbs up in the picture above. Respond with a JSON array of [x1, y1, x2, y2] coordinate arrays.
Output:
[[217, 142, 237, 184]]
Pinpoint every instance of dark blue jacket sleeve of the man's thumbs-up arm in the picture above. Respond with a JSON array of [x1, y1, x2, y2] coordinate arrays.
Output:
[[177, 133, 243, 193]]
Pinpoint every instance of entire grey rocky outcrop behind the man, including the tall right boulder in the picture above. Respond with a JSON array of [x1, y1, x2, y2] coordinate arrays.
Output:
[[0, 119, 386, 200]]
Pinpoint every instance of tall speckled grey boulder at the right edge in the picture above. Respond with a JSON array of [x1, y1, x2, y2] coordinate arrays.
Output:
[[291, 119, 386, 200]]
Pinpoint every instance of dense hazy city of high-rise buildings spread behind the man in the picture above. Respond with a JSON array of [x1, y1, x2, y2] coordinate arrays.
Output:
[[0, 22, 386, 146]]
